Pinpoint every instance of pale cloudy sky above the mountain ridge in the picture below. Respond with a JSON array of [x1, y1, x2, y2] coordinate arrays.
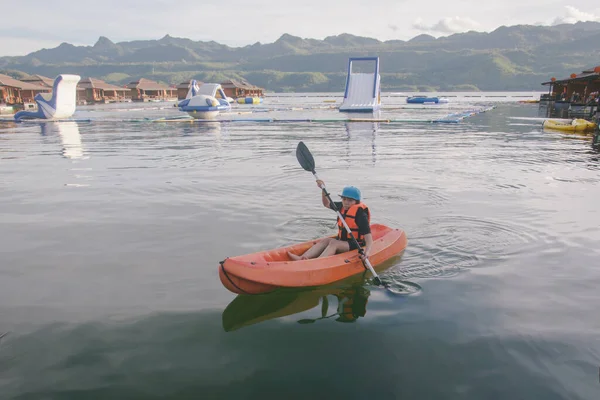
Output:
[[0, 0, 600, 57]]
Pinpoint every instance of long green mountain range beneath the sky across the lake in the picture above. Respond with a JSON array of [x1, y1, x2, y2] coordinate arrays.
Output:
[[0, 22, 600, 91]]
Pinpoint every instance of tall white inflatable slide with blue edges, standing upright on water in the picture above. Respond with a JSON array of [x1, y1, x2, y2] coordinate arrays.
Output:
[[340, 57, 381, 112]]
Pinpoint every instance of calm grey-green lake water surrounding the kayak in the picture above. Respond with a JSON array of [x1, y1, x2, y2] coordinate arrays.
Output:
[[0, 93, 600, 400]]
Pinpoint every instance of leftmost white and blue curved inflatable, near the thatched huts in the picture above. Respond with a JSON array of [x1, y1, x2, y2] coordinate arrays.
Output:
[[15, 74, 81, 121]]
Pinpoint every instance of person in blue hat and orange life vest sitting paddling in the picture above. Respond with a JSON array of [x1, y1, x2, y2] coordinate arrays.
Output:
[[288, 180, 373, 261]]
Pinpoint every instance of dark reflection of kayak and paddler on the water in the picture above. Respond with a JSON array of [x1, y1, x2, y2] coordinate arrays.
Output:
[[222, 274, 371, 332]]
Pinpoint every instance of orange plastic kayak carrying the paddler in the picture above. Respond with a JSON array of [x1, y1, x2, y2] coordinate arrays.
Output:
[[219, 224, 407, 294]]
